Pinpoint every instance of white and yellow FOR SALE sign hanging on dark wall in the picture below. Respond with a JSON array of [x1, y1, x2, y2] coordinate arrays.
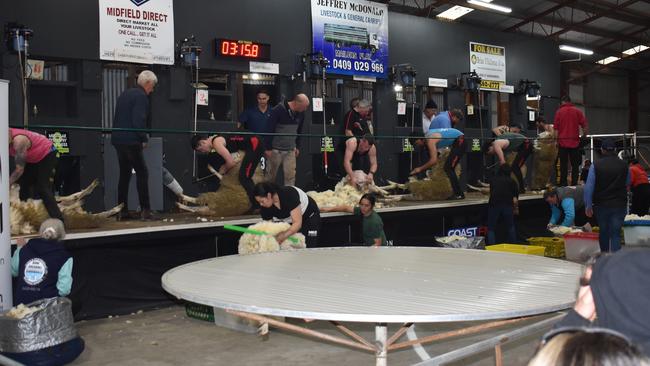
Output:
[[469, 42, 506, 91]]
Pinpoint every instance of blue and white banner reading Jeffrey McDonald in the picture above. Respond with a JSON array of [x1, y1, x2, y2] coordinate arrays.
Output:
[[311, 0, 388, 78]]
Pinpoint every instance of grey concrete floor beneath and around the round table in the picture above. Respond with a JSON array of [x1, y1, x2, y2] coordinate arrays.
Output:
[[72, 306, 543, 366]]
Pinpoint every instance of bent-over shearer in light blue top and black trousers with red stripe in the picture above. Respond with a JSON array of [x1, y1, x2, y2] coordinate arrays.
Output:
[[410, 128, 465, 199]]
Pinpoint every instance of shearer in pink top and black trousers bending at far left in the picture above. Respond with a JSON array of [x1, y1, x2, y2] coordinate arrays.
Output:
[[9, 128, 63, 221]]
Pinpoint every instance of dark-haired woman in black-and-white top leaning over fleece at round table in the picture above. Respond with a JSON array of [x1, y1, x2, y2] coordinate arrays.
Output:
[[254, 182, 321, 248]]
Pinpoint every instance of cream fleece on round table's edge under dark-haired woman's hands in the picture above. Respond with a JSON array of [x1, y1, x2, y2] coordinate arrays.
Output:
[[238, 221, 306, 254]]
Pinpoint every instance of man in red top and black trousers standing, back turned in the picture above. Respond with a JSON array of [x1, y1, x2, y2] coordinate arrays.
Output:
[[553, 95, 588, 186]]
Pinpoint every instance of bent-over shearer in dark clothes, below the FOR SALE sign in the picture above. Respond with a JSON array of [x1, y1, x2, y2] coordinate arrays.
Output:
[[482, 132, 533, 193]]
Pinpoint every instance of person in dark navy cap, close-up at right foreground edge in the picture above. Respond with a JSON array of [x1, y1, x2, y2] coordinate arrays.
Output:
[[554, 248, 650, 356]]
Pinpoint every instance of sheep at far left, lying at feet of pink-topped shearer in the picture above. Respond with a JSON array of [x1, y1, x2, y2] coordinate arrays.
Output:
[[9, 179, 122, 235]]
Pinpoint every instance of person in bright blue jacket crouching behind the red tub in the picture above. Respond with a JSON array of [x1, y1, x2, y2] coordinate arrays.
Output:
[[544, 186, 586, 226]]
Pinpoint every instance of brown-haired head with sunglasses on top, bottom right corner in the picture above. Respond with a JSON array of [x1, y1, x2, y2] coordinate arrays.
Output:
[[528, 328, 650, 366]]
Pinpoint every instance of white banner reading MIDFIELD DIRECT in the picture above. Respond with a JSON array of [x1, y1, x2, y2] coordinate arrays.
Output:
[[99, 0, 174, 65]]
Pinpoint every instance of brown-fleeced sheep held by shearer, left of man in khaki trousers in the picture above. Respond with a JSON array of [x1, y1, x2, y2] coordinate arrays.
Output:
[[176, 151, 264, 217]]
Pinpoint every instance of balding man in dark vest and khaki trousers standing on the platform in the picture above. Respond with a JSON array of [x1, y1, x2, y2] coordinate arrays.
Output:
[[264, 94, 309, 186]]
